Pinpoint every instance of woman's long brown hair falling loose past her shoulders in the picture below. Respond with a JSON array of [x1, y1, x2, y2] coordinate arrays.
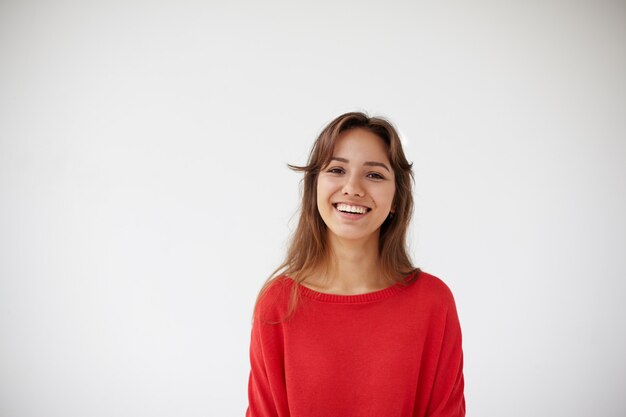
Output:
[[254, 112, 417, 320]]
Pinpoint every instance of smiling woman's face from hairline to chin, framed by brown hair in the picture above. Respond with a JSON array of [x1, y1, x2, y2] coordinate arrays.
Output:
[[317, 128, 396, 242]]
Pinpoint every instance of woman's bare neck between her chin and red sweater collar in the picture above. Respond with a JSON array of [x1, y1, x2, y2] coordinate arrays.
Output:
[[307, 234, 389, 295]]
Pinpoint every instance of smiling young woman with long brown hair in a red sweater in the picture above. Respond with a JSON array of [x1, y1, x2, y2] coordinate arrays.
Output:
[[246, 113, 465, 417]]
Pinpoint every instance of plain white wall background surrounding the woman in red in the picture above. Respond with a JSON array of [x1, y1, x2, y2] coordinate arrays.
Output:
[[0, 0, 626, 417]]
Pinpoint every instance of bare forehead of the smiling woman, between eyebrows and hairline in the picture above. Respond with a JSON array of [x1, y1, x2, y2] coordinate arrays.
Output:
[[333, 128, 389, 163]]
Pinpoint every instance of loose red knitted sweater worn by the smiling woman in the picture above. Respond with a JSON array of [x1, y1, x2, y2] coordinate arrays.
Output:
[[246, 272, 465, 417]]
